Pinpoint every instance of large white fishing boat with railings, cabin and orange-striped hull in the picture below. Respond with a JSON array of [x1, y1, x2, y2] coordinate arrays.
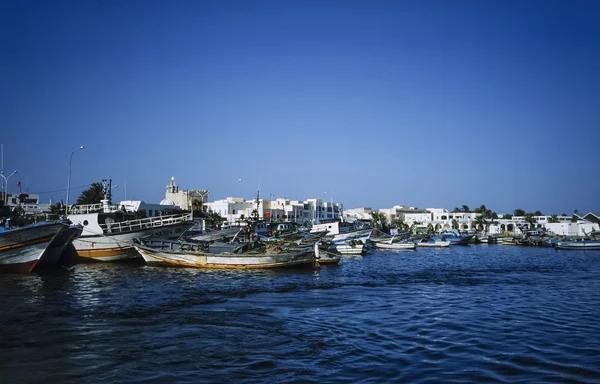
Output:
[[68, 180, 193, 261]]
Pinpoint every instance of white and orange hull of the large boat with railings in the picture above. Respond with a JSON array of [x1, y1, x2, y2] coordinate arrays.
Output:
[[73, 222, 192, 261]]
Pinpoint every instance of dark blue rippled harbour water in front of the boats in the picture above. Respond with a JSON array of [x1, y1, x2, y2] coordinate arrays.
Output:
[[0, 245, 600, 383]]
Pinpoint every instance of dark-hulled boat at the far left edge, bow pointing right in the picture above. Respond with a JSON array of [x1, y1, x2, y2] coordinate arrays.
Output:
[[0, 221, 82, 273]]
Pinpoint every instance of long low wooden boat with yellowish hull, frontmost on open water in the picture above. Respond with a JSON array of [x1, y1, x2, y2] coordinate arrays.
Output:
[[135, 239, 315, 269]]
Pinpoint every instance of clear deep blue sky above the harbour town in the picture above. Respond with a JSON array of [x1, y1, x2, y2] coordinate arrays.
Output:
[[0, 0, 600, 214]]
